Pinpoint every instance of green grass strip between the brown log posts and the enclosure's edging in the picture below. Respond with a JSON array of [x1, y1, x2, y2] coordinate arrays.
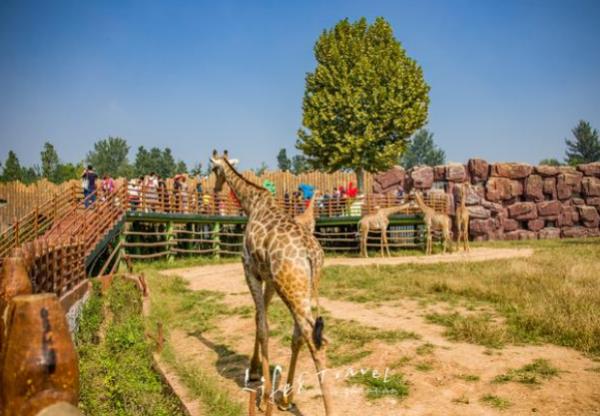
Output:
[[76, 278, 181, 416]]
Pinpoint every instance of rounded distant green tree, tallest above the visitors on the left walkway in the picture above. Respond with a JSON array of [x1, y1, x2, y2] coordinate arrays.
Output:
[[86, 137, 130, 177]]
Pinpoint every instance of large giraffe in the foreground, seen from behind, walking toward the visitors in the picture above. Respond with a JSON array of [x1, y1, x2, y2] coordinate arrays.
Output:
[[211, 151, 335, 416]]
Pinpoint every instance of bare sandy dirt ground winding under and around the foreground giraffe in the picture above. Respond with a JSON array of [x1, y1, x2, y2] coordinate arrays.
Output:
[[156, 249, 600, 416]]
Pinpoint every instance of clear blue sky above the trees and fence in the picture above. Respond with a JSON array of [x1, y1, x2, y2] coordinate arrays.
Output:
[[0, 0, 600, 168]]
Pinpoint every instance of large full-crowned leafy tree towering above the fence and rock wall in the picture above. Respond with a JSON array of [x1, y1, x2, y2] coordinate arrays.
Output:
[[296, 17, 429, 191]]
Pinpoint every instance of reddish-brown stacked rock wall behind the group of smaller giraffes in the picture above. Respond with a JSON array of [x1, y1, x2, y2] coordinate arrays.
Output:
[[374, 159, 600, 240]]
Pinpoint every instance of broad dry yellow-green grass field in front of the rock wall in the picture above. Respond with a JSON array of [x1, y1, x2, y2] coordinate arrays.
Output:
[[321, 238, 600, 355]]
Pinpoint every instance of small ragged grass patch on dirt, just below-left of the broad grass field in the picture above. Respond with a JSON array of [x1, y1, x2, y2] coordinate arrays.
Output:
[[425, 312, 514, 348]]
